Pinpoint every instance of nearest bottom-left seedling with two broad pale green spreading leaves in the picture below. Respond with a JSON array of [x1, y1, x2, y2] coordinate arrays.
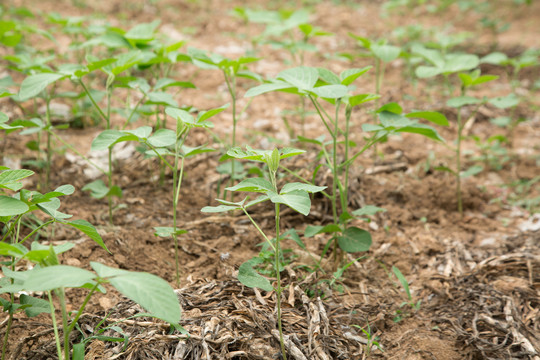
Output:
[[0, 256, 185, 360]]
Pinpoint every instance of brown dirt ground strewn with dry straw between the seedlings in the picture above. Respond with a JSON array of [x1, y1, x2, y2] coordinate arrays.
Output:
[[0, 0, 540, 360]]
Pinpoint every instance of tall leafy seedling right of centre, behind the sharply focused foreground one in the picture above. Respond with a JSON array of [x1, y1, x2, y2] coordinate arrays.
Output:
[[246, 67, 448, 269]]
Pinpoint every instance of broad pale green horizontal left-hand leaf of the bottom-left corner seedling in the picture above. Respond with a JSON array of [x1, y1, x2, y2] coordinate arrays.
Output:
[[22, 265, 96, 291]]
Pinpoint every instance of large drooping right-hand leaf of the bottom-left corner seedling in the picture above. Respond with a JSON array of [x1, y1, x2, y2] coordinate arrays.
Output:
[[90, 262, 181, 325]]
